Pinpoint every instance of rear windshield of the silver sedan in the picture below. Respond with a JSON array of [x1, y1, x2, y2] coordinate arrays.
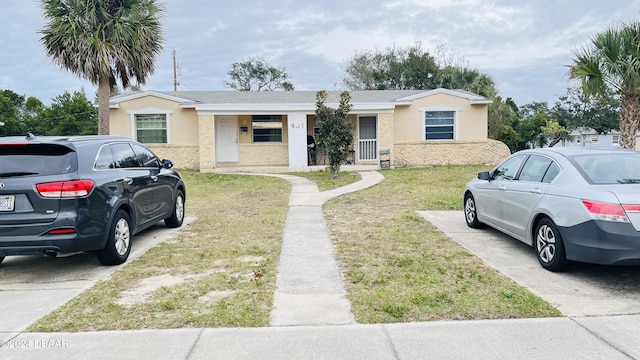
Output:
[[571, 152, 640, 184]]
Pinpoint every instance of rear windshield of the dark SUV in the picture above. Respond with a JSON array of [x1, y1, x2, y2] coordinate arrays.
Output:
[[0, 144, 78, 178]]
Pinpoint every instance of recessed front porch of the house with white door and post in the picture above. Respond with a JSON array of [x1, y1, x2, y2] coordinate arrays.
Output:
[[198, 111, 388, 172]]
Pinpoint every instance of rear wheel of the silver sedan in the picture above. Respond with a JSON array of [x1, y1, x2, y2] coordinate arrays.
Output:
[[533, 218, 569, 272]]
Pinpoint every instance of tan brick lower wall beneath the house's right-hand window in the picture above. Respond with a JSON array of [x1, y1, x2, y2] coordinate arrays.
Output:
[[391, 140, 511, 167]]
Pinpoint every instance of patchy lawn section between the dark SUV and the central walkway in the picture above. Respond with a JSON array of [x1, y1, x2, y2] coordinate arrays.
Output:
[[30, 171, 291, 331]]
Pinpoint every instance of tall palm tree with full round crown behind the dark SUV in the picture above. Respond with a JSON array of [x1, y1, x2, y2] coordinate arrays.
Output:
[[40, 0, 164, 134]]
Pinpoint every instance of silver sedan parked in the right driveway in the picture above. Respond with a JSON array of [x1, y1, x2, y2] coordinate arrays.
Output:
[[463, 148, 640, 271]]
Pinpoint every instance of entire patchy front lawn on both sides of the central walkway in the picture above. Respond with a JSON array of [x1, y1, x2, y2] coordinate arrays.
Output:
[[29, 166, 560, 331]]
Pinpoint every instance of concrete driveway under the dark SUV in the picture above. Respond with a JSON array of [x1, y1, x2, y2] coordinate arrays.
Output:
[[0, 217, 194, 340]]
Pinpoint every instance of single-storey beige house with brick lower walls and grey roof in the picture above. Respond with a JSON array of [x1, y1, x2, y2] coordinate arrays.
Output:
[[110, 89, 509, 171]]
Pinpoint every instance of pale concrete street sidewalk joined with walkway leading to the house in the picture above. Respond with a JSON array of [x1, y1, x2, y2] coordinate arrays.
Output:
[[0, 172, 640, 360]]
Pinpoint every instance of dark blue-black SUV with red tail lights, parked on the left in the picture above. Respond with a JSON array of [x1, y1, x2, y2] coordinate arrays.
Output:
[[0, 134, 186, 265]]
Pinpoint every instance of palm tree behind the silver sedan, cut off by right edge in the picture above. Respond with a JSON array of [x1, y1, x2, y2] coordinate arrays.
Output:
[[569, 22, 640, 149]]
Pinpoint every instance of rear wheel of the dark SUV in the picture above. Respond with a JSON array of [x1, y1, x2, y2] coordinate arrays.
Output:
[[96, 209, 132, 265]]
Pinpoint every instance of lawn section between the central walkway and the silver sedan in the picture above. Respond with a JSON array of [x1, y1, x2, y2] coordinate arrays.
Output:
[[324, 166, 560, 323]]
